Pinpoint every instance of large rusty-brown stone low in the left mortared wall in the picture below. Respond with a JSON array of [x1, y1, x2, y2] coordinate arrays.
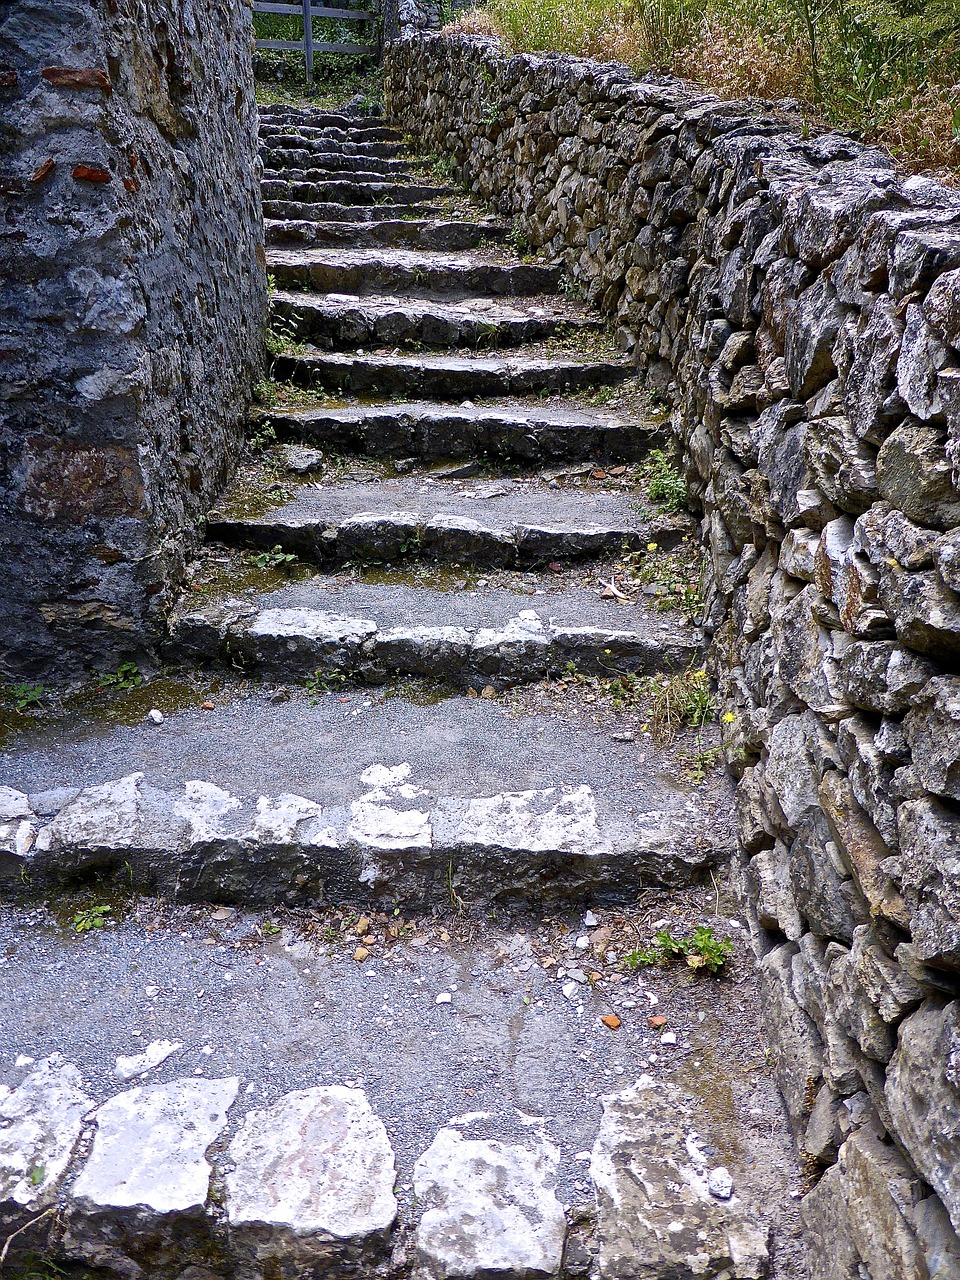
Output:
[[18, 435, 146, 521]]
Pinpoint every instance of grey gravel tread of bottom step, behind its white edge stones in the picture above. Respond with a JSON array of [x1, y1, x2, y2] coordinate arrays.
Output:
[[0, 886, 801, 1280]]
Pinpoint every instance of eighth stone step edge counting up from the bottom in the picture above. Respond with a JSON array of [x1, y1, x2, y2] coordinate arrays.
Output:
[[268, 248, 563, 297]]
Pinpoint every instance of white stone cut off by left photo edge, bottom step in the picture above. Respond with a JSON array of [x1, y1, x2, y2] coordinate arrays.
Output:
[[0, 1055, 93, 1224]]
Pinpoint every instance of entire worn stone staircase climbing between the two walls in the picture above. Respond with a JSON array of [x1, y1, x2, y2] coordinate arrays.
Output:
[[0, 106, 797, 1280]]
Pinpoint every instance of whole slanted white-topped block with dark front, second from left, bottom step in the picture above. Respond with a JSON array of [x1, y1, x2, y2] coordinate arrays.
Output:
[[63, 1078, 239, 1280]]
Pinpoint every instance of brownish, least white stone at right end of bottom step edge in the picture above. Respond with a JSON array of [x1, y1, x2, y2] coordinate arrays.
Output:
[[590, 1075, 768, 1280]]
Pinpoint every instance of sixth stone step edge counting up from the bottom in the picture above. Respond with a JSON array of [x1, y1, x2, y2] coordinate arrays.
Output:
[[273, 352, 635, 401]]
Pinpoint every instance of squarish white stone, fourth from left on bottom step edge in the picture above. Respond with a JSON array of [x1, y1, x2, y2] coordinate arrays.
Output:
[[413, 1129, 566, 1280]]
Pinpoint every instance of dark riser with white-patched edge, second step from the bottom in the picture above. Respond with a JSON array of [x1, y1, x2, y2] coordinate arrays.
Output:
[[20, 788, 728, 910]]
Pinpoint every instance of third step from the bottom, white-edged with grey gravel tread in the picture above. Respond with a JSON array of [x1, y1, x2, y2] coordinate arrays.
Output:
[[164, 575, 704, 689]]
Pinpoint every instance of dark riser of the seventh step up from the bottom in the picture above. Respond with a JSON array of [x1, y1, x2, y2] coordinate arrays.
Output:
[[271, 297, 595, 349]]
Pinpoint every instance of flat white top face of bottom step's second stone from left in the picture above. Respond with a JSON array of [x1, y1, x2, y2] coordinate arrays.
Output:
[[70, 1076, 239, 1215]]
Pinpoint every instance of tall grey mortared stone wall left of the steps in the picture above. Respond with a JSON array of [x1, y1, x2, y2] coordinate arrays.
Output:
[[0, 0, 266, 677]]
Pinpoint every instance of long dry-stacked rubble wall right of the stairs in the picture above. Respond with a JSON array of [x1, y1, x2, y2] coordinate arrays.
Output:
[[387, 35, 960, 1280]]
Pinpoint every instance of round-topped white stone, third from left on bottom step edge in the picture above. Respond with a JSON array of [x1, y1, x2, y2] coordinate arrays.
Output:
[[224, 1085, 397, 1277]]
